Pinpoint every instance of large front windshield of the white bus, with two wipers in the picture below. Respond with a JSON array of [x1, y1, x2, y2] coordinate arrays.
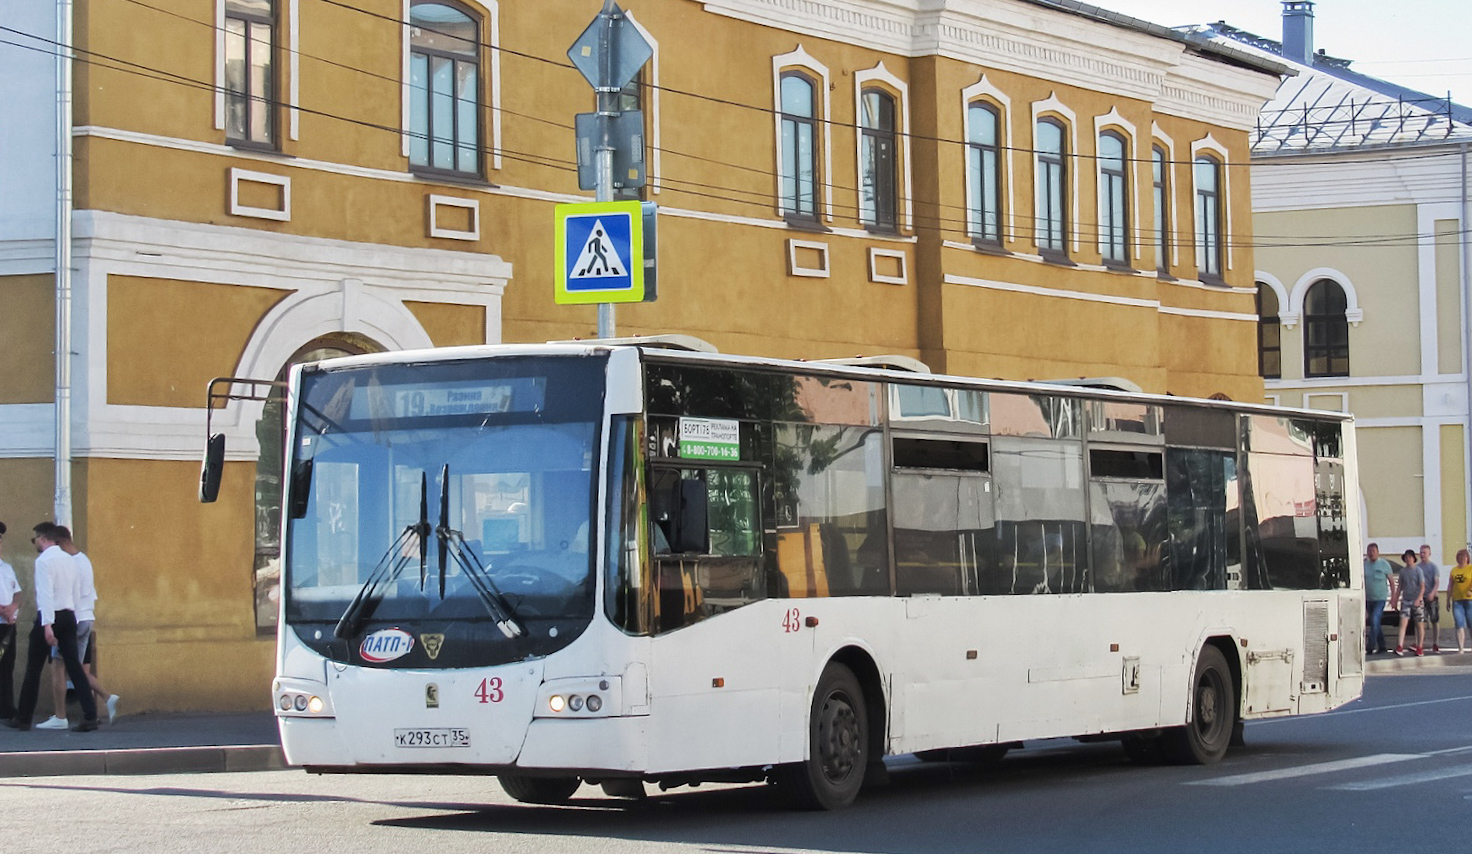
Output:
[[284, 356, 604, 667]]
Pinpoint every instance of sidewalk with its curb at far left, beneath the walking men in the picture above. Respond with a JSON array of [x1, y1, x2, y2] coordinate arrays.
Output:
[[0, 711, 286, 777]]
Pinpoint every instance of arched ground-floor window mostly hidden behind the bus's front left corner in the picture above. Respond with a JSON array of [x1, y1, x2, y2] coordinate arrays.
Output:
[[252, 333, 383, 633]]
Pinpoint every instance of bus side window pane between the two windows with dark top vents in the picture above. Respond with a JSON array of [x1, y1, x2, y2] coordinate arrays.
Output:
[[982, 435, 1089, 593]]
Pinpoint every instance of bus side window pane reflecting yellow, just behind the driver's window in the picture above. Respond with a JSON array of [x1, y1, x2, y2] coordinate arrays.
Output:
[[773, 424, 889, 596]]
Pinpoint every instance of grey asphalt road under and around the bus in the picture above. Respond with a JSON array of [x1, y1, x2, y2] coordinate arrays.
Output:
[[0, 667, 1472, 854]]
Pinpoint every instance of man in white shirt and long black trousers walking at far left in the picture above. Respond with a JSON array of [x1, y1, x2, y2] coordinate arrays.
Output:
[[4, 521, 97, 732]]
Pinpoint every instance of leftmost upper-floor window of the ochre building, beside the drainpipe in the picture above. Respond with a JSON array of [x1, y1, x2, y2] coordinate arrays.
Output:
[[225, 0, 277, 147]]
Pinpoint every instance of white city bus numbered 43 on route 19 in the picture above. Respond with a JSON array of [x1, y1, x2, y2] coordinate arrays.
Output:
[[247, 340, 1365, 808]]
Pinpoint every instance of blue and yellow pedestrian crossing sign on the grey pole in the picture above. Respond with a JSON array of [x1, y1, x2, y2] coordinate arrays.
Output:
[[555, 199, 645, 305]]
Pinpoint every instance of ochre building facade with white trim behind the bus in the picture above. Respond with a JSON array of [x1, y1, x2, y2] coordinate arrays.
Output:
[[0, 0, 1284, 711]]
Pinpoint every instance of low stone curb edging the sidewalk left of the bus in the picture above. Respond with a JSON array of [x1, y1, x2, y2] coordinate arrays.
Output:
[[0, 745, 289, 777]]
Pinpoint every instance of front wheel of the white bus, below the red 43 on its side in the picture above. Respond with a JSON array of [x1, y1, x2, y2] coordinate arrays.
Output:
[[776, 663, 868, 810]]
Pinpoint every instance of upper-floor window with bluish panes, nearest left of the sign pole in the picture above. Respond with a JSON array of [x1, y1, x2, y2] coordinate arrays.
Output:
[[409, 1, 481, 175]]
